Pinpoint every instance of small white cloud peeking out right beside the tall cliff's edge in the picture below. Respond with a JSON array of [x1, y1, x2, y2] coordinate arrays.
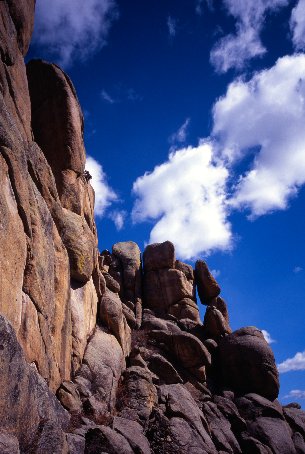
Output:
[[86, 156, 118, 216]]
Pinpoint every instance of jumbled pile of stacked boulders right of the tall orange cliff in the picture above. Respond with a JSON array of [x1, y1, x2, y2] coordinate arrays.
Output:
[[51, 241, 305, 454]]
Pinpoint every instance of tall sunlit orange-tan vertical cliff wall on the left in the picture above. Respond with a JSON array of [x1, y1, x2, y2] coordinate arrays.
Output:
[[0, 0, 99, 390]]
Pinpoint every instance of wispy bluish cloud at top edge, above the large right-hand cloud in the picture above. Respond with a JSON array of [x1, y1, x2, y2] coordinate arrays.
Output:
[[210, 0, 289, 73]]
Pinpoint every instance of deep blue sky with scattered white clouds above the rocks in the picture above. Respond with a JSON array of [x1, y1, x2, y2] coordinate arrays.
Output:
[[28, 0, 305, 406]]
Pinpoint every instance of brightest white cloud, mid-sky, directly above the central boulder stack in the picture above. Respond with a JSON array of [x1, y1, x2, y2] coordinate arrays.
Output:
[[132, 142, 232, 259]]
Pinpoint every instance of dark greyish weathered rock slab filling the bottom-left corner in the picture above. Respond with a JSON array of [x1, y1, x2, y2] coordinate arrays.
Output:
[[0, 316, 69, 454]]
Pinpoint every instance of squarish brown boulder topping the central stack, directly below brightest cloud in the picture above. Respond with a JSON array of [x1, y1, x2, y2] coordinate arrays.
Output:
[[143, 241, 176, 273]]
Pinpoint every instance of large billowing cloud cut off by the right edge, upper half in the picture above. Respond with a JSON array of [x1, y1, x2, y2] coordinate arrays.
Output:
[[213, 54, 305, 217]]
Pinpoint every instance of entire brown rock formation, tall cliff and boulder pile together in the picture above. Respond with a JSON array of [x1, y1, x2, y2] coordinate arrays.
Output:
[[0, 0, 305, 454]]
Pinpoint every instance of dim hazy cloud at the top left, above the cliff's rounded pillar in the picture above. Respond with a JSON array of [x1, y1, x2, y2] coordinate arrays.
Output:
[[33, 0, 116, 66]]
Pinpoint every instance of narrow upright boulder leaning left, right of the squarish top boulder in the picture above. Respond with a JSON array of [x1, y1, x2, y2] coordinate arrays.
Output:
[[195, 260, 220, 305]]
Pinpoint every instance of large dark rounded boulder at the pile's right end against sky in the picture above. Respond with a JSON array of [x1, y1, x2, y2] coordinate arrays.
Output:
[[219, 327, 279, 400]]
